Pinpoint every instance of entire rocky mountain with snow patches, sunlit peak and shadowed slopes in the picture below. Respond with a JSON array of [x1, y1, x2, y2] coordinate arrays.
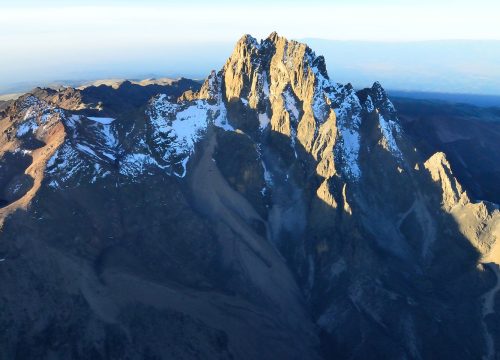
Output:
[[0, 33, 500, 359]]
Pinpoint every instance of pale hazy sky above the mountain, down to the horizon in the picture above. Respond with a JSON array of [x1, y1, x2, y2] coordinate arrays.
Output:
[[0, 0, 500, 95]]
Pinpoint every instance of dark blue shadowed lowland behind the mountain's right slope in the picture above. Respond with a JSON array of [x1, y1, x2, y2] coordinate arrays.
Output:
[[394, 98, 500, 204]]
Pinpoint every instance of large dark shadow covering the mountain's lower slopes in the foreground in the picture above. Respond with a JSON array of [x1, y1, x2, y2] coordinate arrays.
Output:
[[0, 88, 497, 359]]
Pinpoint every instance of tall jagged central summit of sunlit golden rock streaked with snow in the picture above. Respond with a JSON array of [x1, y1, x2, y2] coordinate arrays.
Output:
[[156, 33, 401, 180]]
